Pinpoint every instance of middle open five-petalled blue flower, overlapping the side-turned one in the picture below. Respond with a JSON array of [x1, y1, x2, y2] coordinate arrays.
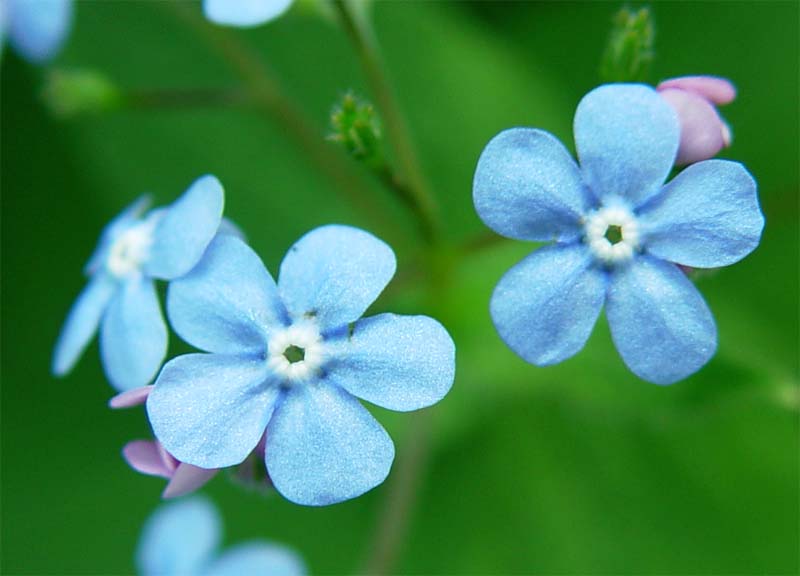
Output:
[[147, 226, 455, 506]]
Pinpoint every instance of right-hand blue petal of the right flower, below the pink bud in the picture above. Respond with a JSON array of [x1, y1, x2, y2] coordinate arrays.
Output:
[[640, 160, 764, 268]]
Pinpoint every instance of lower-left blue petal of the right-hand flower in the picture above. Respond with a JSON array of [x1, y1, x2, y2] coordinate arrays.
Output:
[[489, 244, 606, 366]]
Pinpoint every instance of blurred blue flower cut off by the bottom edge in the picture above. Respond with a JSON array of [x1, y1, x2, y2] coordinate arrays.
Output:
[[136, 497, 306, 576]]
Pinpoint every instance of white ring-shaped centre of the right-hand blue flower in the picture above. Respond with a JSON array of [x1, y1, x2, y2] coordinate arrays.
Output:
[[584, 206, 639, 264]]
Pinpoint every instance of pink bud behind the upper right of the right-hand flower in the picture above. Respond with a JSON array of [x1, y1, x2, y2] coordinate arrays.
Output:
[[656, 76, 736, 166]]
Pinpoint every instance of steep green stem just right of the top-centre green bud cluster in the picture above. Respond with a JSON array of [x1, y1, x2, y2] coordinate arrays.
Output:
[[333, 0, 440, 244]]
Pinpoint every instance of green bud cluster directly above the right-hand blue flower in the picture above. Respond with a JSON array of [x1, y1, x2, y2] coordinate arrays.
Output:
[[600, 7, 655, 82]]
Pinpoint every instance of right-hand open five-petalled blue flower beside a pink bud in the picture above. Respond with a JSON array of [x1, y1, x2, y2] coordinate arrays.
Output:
[[473, 85, 764, 384]]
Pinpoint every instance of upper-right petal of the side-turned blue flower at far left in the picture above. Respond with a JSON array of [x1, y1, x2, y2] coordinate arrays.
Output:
[[145, 176, 225, 280]]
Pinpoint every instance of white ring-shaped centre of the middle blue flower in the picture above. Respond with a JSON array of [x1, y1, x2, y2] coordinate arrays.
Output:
[[267, 321, 325, 385]]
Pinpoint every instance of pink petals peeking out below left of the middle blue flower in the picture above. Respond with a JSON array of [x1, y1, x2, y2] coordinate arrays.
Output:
[[108, 386, 219, 499]]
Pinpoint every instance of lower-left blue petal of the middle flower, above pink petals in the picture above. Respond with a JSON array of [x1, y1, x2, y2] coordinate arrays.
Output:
[[147, 354, 279, 468]]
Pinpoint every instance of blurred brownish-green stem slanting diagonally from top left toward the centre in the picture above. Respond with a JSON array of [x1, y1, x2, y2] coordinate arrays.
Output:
[[164, 2, 399, 237]]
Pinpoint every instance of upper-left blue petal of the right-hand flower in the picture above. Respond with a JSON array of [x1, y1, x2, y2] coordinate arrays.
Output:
[[472, 128, 587, 240]]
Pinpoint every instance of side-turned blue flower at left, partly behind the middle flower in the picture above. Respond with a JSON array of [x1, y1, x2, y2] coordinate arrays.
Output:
[[52, 176, 224, 390]]
